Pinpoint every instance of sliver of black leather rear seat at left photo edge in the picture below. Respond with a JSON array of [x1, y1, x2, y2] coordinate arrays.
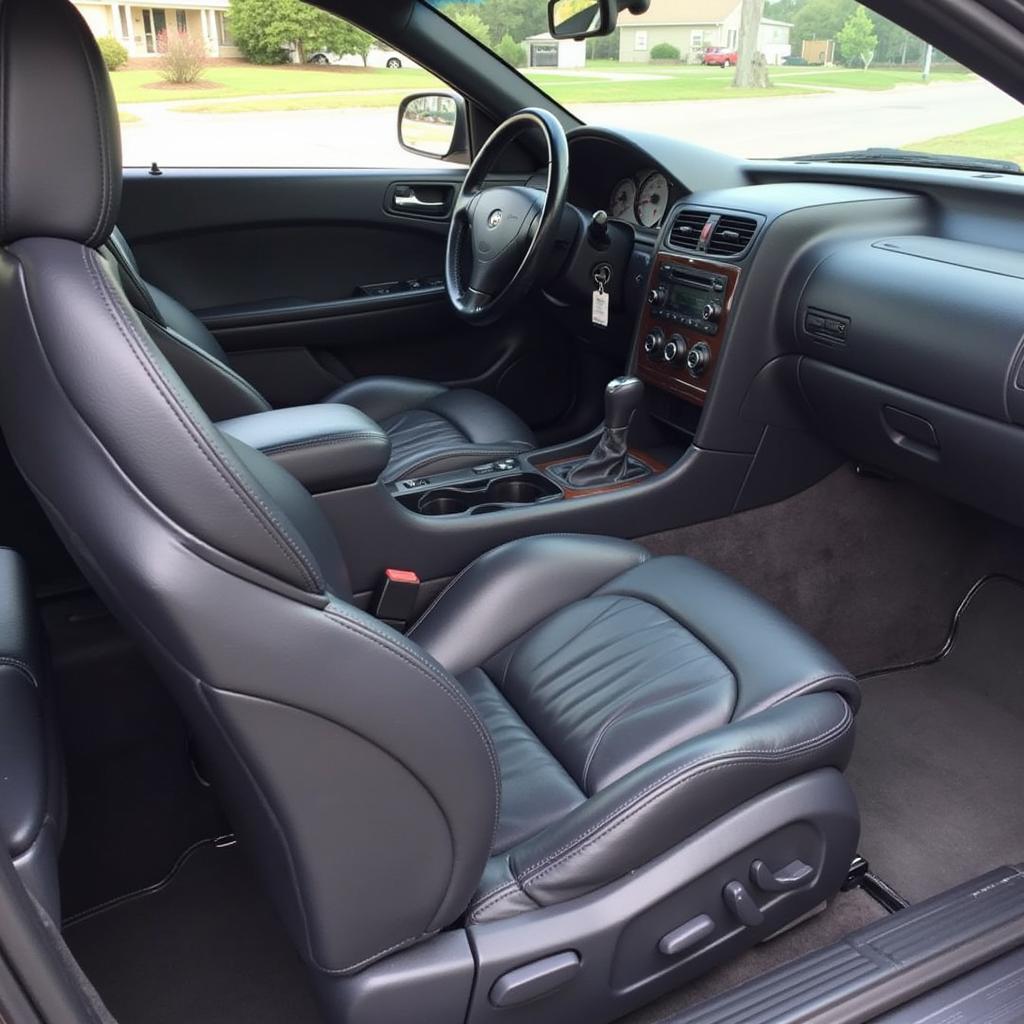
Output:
[[0, 548, 63, 921]]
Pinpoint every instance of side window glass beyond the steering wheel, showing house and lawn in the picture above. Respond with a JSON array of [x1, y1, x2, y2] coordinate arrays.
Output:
[[81, 0, 458, 167]]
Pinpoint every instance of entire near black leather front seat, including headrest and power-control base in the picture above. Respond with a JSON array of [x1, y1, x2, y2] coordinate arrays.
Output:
[[0, 0, 858, 1024]]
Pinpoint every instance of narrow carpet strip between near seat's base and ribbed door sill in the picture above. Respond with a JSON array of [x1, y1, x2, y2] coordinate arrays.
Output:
[[618, 890, 886, 1024]]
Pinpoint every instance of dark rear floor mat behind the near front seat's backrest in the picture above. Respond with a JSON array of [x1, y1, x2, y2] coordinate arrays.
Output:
[[65, 846, 322, 1024]]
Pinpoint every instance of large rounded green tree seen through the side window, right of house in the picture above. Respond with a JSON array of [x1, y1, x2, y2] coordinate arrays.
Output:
[[230, 0, 374, 63]]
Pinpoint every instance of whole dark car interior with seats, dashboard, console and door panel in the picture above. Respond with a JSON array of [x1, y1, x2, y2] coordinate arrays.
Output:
[[0, 0, 1024, 1024]]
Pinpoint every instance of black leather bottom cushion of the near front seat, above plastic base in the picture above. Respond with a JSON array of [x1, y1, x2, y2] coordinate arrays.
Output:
[[412, 537, 859, 922]]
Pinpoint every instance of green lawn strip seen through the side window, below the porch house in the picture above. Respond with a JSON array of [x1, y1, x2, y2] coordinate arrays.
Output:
[[111, 65, 439, 103]]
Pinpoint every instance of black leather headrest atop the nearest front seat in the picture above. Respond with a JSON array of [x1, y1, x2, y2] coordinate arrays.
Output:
[[0, 0, 121, 246]]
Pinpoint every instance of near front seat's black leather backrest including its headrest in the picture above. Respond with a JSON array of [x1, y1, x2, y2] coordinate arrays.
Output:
[[0, 0, 499, 973]]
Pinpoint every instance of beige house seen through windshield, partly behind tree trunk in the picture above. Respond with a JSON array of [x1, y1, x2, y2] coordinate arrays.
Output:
[[618, 0, 793, 63]]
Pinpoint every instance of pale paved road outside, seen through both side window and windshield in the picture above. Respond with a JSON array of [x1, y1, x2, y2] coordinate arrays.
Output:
[[123, 80, 1024, 168]]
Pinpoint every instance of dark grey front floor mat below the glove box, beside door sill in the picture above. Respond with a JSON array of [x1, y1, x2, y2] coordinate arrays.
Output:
[[848, 579, 1024, 902]]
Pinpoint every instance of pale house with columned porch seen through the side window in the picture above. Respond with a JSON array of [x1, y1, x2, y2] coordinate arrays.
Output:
[[75, 0, 241, 57]]
